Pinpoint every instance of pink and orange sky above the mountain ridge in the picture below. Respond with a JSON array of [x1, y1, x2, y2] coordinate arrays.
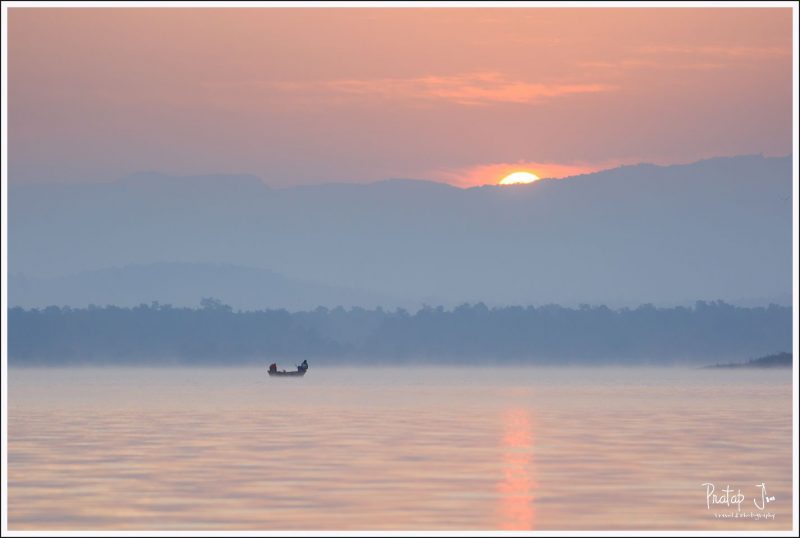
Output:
[[8, 7, 792, 187]]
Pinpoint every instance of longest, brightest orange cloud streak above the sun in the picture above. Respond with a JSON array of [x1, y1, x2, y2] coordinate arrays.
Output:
[[277, 72, 616, 106]]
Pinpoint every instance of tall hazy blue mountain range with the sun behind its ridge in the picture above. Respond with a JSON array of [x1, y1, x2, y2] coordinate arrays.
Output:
[[8, 156, 792, 307]]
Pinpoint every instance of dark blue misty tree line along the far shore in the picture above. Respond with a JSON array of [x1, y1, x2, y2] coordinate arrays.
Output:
[[8, 298, 792, 365]]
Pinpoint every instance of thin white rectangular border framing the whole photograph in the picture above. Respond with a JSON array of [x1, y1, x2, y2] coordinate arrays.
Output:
[[0, 1, 800, 537]]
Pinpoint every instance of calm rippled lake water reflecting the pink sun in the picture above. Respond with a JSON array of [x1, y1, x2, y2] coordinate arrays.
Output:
[[8, 364, 792, 530]]
